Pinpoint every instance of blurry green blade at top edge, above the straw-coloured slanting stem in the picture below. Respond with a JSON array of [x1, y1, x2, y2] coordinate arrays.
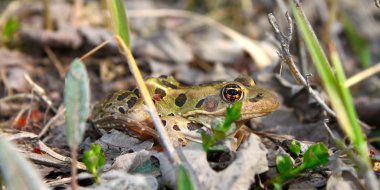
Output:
[[107, 0, 130, 47]]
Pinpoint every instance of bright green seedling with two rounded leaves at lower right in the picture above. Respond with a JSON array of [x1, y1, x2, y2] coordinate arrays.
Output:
[[271, 143, 329, 189]]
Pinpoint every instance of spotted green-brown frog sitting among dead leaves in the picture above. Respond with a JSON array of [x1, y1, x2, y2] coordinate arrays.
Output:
[[92, 75, 279, 146]]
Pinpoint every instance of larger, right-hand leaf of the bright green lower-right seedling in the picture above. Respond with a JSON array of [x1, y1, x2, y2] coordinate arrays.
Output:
[[301, 143, 330, 169]]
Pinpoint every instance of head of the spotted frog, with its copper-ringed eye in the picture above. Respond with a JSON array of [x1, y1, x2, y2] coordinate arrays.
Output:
[[183, 76, 279, 123]]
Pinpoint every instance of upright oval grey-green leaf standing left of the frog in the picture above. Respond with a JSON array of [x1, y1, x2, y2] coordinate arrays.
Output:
[[64, 59, 90, 149]]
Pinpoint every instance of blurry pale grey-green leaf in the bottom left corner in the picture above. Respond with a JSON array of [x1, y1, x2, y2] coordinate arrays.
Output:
[[0, 137, 48, 190]]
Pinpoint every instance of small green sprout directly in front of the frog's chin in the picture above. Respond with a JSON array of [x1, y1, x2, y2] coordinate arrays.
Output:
[[202, 102, 242, 152]]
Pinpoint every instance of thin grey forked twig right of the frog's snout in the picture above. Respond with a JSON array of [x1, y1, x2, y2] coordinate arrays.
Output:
[[268, 13, 336, 117]]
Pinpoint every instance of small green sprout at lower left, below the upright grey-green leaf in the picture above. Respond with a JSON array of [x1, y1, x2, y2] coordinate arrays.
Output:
[[83, 144, 106, 183]]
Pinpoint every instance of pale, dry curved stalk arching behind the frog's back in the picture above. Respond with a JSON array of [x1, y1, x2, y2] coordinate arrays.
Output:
[[128, 9, 273, 68]]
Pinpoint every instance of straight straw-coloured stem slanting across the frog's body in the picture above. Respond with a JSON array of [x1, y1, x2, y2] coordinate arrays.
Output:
[[115, 35, 181, 165]]
